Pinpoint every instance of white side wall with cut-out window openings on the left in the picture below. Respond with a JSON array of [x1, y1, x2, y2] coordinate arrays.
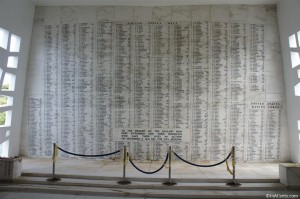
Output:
[[0, 0, 34, 156]]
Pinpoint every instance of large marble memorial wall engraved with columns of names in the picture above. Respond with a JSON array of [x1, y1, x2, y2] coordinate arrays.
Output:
[[22, 5, 288, 161]]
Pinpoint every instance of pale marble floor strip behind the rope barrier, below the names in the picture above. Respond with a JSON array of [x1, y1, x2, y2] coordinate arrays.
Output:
[[22, 158, 279, 179]]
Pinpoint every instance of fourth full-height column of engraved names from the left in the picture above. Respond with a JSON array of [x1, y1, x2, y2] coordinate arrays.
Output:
[[94, 22, 113, 154]]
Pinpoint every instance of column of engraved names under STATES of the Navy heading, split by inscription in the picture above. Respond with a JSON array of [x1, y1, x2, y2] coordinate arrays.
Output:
[[152, 22, 171, 159]]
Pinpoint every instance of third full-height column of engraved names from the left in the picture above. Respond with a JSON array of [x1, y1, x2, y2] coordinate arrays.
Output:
[[77, 23, 94, 154]]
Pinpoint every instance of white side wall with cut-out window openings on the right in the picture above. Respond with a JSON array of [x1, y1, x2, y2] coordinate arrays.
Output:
[[277, 0, 300, 163]]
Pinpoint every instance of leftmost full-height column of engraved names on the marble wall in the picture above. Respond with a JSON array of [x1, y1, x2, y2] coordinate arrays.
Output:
[[43, 25, 60, 156]]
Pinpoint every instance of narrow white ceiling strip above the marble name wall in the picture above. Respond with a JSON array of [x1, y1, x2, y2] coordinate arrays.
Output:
[[32, 0, 278, 6]]
